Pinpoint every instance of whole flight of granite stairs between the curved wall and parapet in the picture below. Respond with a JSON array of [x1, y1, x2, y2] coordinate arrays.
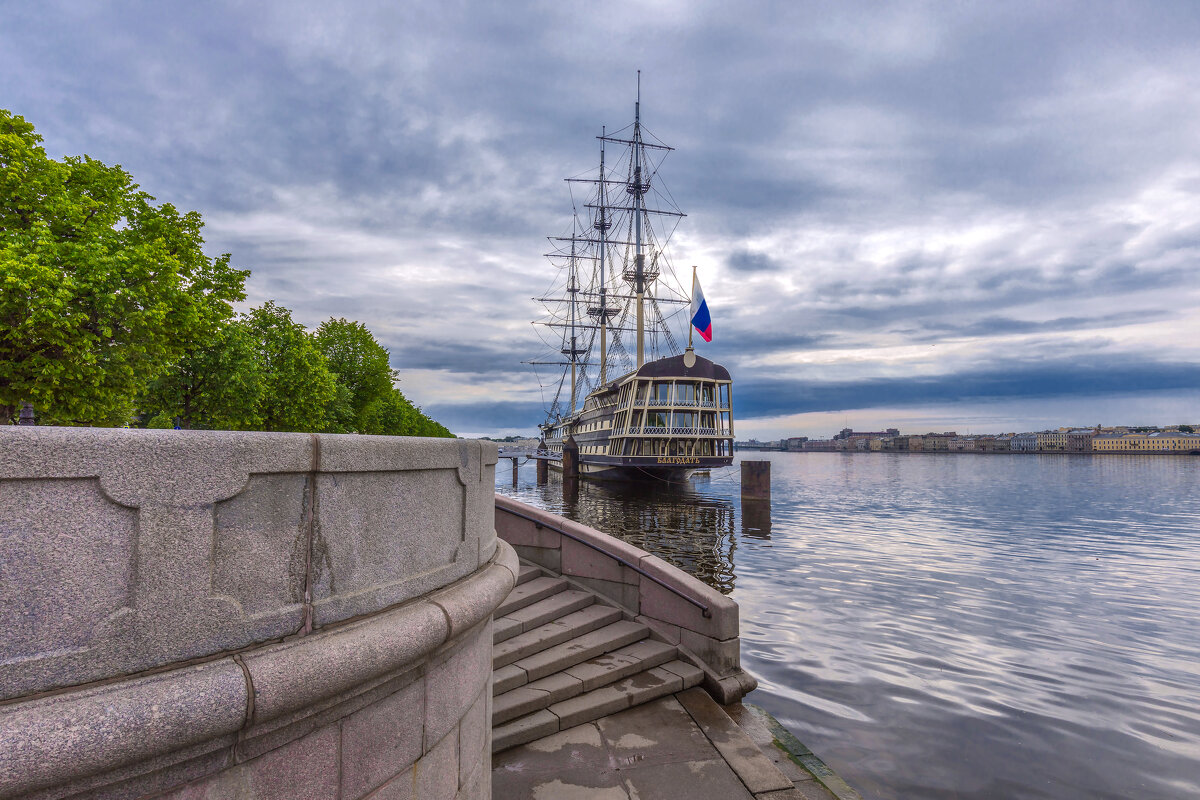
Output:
[[492, 565, 703, 753]]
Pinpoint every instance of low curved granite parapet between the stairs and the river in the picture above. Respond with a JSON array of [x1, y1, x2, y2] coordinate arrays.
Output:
[[496, 494, 756, 704]]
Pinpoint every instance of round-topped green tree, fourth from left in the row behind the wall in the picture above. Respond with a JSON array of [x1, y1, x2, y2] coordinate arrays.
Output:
[[313, 318, 396, 432]]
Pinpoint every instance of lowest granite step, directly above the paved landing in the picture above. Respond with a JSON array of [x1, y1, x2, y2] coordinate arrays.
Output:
[[492, 660, 704, 753]]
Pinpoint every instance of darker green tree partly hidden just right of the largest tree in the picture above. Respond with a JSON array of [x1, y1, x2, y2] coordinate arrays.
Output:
[[138, 319, 264, 431]]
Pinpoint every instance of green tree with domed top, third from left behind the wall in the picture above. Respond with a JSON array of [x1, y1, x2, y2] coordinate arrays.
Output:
[[246, 301, 338, 432]]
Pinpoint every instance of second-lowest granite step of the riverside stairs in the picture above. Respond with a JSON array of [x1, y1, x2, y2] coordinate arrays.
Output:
[[492, 639, 678, 726]]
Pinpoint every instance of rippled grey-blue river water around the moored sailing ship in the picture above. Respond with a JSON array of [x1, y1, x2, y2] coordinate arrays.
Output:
[[497, 452, 1200, 800]]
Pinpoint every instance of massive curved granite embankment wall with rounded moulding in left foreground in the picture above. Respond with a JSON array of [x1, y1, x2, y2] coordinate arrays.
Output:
[[0, 427, 517, 800]]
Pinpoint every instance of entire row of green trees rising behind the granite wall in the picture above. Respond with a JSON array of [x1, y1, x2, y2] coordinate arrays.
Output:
[[0, 109, 452, 437]]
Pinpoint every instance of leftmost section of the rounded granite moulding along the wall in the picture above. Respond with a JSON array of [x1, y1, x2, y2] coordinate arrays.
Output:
[[0, 658, 246, 796]]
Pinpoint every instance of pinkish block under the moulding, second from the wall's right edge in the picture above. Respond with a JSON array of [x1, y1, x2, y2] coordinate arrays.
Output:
[[342, 680, 425, 799]]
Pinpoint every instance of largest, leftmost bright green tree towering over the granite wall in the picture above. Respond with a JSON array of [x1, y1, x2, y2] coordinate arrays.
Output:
[[0, 109, 248, 425]]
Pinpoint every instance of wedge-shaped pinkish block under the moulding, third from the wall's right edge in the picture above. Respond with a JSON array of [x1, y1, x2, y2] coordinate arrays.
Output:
[[160, 724, 340, 800]]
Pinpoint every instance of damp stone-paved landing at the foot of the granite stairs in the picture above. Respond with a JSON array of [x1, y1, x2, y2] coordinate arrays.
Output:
[[492, 688, 860, 800]]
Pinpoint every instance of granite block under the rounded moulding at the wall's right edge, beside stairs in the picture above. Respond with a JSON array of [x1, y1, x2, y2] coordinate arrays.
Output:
[[425, 620, 492, 750]]
